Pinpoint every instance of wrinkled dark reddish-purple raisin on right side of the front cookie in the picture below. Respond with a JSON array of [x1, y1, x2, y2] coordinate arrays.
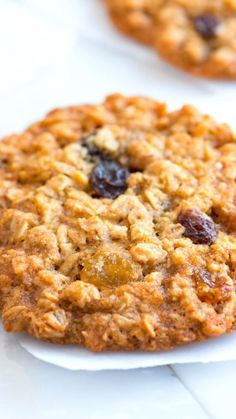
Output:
[[178, 209, 217, 245]]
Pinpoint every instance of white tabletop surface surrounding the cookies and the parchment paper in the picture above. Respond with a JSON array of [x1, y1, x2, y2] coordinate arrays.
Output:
[[0, 0, 236, 419]]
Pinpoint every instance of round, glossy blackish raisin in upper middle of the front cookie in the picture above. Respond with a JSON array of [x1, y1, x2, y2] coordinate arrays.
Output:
[[90, 160, 129, 199]]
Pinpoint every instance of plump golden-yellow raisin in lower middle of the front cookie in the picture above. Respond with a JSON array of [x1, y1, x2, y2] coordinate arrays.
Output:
[[81, 246, 142, 288]]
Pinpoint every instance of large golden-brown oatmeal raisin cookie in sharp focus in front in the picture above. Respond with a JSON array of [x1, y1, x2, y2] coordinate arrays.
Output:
[[0, 95, 236, 351]]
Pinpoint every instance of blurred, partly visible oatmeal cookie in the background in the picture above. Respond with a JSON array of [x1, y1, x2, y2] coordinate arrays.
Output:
[[105, 0, 236, 79]]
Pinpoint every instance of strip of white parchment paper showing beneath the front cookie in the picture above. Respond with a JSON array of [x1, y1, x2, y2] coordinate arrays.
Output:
[[20, 333, 236, 371]]
